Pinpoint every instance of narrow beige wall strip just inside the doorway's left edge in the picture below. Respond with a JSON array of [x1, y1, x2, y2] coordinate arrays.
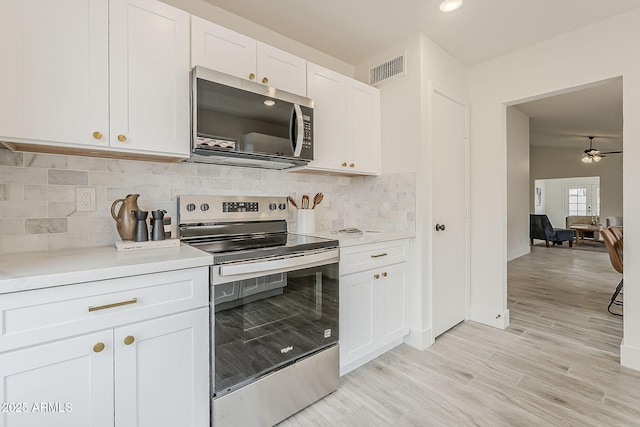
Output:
[[507, 107, 531, 260]]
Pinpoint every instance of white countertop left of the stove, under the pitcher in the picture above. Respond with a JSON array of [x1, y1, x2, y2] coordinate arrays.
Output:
[[0, 244, 213, 294]]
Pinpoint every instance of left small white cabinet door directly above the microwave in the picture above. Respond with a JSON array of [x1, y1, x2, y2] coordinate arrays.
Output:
[[191, 16, 256, 81]]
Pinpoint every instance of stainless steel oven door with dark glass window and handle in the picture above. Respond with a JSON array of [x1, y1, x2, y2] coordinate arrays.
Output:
[[211, 249, 339, 398]]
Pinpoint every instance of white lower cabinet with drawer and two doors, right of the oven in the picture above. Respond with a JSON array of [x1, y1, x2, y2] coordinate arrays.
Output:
[[340, 240, 409, 375]]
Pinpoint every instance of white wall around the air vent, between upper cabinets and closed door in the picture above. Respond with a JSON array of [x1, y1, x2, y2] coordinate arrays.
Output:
[[355, 34, 468, 348]]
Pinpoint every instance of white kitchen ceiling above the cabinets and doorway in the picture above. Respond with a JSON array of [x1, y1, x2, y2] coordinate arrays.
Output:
[[205, 0, 640, 65]]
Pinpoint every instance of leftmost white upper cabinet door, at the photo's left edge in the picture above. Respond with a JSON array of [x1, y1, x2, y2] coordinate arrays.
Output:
[[0, 0, 109, 146]]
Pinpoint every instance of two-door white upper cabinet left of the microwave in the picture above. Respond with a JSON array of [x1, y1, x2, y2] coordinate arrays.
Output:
[[0, 0, 190, 159]]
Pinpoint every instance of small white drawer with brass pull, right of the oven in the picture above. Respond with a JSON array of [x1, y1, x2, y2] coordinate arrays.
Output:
[[340, 239, 409, 275]]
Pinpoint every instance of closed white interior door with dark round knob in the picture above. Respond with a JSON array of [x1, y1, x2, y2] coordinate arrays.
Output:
[[431, 91, 468, 337]]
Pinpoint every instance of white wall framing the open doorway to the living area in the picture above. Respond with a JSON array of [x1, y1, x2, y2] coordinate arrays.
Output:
[[469, 10, 640, 369]]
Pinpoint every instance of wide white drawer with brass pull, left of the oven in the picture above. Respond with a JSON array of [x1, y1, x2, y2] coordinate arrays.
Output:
[[0, 267, 209, 352]]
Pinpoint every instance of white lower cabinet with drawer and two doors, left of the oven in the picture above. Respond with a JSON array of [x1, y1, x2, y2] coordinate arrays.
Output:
[[0, 267, 209, 427]]
